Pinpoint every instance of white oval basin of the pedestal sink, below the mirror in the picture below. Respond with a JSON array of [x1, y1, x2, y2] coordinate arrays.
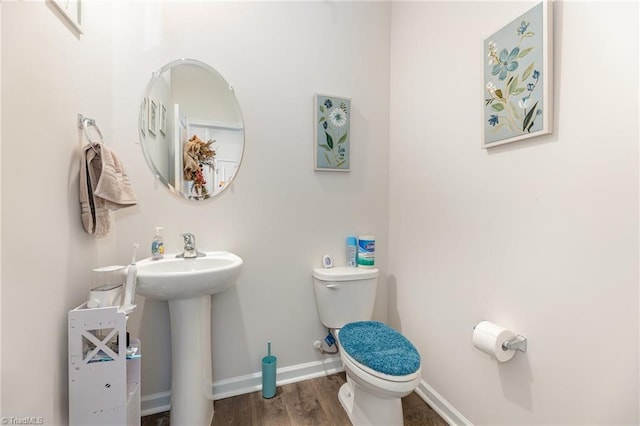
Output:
[[136, 251, 242, 300]]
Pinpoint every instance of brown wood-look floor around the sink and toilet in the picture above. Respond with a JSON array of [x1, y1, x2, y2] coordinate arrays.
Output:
[[142, 373, 447, 426]]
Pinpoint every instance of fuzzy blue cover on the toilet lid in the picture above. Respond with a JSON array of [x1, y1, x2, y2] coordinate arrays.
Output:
[[339, 321, 420, 376]]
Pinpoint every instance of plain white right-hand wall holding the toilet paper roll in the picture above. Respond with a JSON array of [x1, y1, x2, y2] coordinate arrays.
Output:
[[389, 1, 640, 424]]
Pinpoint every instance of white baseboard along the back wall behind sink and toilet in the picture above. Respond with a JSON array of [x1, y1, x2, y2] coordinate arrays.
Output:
[[141, 356, 344, 416]]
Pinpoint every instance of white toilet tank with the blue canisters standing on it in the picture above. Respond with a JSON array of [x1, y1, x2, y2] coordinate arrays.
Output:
[[313, 267, 379, 328]]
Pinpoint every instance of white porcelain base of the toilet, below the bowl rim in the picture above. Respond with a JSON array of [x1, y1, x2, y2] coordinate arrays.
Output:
[[338, 376, 404, 426]]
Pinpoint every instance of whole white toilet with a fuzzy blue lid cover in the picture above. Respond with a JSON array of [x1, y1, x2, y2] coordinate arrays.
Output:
[[313, 267, 421, 426]]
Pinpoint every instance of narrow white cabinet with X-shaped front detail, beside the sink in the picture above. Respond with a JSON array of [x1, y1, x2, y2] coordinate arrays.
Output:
[[69, 304, 140, 426]]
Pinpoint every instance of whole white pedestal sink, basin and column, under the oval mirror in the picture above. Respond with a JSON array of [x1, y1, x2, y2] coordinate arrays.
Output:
[[136, 251, 242, 426]]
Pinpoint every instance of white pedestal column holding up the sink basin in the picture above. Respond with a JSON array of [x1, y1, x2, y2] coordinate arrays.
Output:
[[169, 295, 213, 426]]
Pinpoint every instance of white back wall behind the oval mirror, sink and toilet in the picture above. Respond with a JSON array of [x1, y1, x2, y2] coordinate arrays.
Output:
[[113, 2, 390, 394]]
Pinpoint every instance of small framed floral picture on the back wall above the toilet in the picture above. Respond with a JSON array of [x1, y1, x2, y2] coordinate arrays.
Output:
[[313, 94, 351, 172]]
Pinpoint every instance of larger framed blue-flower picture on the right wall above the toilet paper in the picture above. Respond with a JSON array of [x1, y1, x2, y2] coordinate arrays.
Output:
[[482, 0, 553, 148]]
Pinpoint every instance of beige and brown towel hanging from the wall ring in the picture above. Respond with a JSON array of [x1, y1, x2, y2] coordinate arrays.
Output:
[[80, 144, 137, 238]]
